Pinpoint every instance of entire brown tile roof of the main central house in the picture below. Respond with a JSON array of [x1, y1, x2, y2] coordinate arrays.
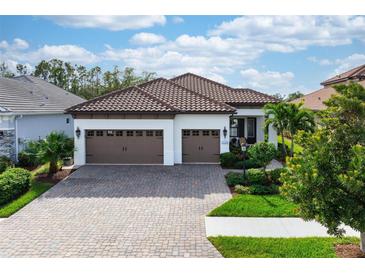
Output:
[[66, 73, 278, 113]]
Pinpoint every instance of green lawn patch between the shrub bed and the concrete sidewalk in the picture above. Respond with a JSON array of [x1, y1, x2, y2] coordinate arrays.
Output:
[[208, 194, 298, 217]]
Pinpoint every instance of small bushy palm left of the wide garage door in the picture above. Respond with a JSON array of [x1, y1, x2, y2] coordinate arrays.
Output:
[[28, 131, 74, 176]]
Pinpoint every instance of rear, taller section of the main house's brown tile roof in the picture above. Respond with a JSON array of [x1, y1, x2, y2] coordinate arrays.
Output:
[[171, 73, 278, 106]]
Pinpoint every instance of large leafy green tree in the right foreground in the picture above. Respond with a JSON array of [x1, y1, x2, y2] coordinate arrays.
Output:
[[280, 83, 365, 251]]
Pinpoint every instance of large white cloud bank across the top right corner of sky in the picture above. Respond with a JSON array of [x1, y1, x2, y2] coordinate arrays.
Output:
[[208, 16, 365, 52]]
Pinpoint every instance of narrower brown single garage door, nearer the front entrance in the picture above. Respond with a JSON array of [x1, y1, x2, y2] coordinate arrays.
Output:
[[182, 129, 220, 163]]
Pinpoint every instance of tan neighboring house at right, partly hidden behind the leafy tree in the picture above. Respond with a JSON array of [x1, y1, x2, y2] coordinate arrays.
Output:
[[291, 64, 365, 111]]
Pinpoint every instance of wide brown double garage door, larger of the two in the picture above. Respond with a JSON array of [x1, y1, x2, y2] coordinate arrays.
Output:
[[86, 130, 163, 164]]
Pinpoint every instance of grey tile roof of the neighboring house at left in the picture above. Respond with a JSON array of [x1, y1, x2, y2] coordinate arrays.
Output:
[[0, 76, 85, 114]]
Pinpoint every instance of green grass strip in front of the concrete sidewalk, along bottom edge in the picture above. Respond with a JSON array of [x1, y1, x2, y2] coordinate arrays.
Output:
[[208, 237, 359, 258]]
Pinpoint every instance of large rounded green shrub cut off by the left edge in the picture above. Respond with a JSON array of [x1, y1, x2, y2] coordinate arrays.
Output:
[[0, 168, 31, 204]]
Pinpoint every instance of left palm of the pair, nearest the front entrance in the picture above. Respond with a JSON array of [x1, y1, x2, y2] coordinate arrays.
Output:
[[264, 102, 288, 159]]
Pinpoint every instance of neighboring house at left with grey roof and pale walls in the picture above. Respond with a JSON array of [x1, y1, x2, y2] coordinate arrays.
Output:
[[0, 76, 85, 160]]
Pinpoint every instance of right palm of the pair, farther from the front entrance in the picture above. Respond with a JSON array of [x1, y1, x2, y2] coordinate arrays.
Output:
[[286, 103, 315, 157]]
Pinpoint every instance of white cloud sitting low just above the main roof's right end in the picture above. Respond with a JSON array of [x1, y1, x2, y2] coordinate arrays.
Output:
[[240, 68, 294, 93]]
